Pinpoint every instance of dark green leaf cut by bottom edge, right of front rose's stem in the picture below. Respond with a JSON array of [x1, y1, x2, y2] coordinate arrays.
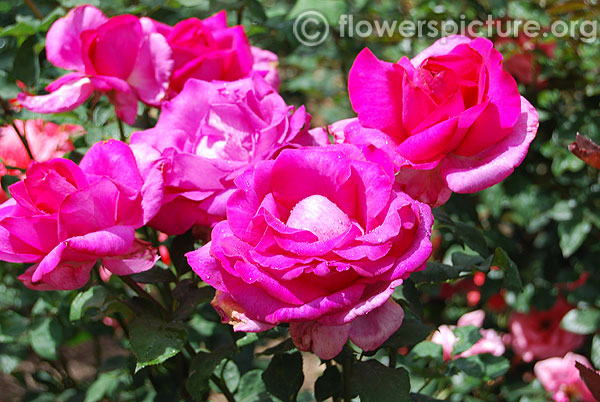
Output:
[[352, 360, 412, 402]]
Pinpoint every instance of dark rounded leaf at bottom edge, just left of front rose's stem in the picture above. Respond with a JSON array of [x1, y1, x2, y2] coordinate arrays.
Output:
[[262, 352, 304, 402]]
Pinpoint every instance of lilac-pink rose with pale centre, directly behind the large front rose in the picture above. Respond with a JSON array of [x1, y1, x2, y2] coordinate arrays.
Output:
[[131, 75, 310, 235]]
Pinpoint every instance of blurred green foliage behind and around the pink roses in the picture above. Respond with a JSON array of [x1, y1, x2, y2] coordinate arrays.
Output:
[[0, 0, 600, 402]]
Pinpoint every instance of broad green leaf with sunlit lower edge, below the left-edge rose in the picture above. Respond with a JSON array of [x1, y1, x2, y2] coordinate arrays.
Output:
[[129, 316, 187, 372]]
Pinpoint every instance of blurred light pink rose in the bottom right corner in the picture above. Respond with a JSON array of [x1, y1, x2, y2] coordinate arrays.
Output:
[[533, 353, 596, 402]]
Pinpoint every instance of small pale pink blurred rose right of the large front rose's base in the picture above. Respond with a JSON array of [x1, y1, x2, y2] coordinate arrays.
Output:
[[431, 310, 505, 361]]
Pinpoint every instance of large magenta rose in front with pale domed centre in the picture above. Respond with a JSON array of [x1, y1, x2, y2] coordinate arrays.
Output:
[[187, 145, 433, 359]]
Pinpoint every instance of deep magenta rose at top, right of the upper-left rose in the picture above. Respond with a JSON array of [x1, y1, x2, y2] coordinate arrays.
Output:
[[141, 11, 279, 96]]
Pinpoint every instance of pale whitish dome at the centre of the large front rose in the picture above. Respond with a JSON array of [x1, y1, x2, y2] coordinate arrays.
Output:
[[287, 194, 352, 241]]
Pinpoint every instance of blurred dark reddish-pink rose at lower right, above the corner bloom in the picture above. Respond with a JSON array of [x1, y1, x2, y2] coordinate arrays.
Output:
[[508, 297, 585, 362]]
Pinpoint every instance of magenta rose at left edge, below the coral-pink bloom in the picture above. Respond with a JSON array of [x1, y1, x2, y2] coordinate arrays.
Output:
[[0, 140, 157, 290]]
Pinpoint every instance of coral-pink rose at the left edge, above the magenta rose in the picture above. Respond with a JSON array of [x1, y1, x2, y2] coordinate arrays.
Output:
[[0, 119, 84, 175]]
